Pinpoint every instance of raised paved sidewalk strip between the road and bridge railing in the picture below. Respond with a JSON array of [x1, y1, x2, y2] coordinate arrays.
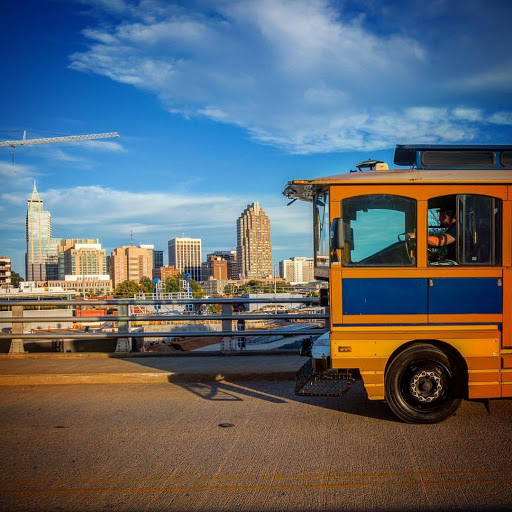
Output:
[[0, 353, 306, 386]]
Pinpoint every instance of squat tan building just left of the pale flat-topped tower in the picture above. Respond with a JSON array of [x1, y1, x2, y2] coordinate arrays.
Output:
[[110, 245, 153, 288]]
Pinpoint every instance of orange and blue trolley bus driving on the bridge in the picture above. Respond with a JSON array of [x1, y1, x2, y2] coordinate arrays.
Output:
[[283, 145, 512, 423]]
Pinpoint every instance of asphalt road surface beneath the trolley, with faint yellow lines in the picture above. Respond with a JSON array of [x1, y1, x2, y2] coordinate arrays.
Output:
[[0, 381, 512, 512]]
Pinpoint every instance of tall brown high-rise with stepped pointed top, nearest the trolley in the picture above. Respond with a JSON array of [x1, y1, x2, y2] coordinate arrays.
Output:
[[236, 201, 272, 279]]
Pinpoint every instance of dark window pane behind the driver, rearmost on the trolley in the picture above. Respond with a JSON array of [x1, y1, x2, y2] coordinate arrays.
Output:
[[457, 194, 501, 266]]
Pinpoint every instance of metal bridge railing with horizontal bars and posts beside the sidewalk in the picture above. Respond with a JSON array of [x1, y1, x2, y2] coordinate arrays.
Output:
[[0, 297, 328, 354]]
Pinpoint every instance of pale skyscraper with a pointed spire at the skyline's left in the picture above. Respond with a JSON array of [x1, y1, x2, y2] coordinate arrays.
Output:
[[25, 182, 61, 281]]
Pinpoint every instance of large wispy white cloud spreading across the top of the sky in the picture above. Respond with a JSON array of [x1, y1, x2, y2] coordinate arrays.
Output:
[[70, 0, 510, 153]]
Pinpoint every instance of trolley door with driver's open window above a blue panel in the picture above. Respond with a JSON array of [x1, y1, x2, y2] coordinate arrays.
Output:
[[428, 194, 503, 324]]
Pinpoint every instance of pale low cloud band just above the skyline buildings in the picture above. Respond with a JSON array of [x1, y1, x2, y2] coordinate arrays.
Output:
[[30, 186, 302, 247]]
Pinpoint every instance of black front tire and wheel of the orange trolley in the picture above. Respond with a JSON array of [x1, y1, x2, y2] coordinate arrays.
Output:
[[385, 343, 463, 423]]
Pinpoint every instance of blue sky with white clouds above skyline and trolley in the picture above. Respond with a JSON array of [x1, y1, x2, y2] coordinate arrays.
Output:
[[0, 0, 512, 274]]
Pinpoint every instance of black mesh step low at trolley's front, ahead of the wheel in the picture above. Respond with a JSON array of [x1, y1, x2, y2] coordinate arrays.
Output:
[[295, 359, 354, 396]]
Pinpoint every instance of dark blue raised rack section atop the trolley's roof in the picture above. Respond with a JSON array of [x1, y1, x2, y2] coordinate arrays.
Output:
[[393, 144, 512, 169]]
